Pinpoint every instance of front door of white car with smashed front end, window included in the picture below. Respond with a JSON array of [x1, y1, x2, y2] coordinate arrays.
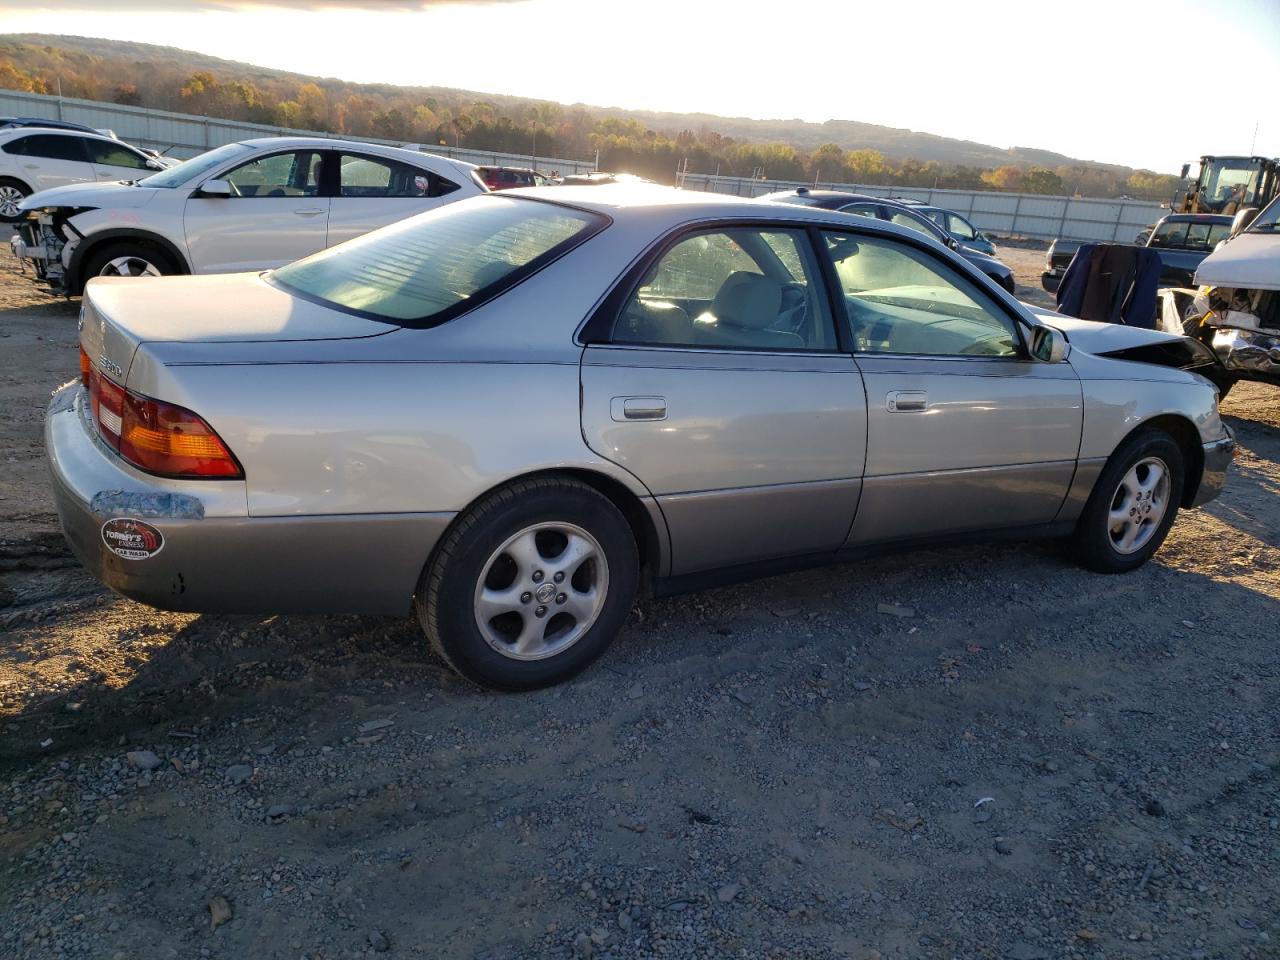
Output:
[[183, 150, 329, 274]]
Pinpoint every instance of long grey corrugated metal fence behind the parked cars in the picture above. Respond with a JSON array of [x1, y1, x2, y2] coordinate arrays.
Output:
[[0, 90, 1166, 243]]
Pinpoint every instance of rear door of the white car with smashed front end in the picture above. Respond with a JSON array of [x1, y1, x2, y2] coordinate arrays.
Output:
[[328, 154, 458, 247]]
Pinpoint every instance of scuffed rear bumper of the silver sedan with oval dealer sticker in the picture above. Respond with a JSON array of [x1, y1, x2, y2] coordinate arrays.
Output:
[[45, 384, 454, 616]]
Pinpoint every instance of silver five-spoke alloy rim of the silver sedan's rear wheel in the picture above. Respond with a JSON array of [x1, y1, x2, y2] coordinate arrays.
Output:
[[474, 522, 609, 660]]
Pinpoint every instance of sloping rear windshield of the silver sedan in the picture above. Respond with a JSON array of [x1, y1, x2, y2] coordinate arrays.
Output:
[[271, 195, 608, 326]]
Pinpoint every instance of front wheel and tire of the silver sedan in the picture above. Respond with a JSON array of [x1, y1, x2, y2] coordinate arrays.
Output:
[[1073, 429, 1185, 573]]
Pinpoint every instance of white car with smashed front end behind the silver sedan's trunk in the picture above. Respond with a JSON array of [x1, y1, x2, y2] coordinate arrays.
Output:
[[10, 137, 488, 296]]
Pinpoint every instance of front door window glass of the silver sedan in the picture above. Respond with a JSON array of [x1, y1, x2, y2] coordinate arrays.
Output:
[[823, 233, 1021, 358]]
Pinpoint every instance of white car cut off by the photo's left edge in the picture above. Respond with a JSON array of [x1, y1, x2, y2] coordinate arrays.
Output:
[[0, 127, 165, 223]]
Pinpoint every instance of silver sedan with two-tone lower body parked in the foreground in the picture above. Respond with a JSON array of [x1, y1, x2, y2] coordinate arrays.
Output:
[[46, 187, 1233, 690]]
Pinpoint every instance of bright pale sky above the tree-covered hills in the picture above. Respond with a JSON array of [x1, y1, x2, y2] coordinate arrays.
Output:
[[0, 0, 1280, 173]]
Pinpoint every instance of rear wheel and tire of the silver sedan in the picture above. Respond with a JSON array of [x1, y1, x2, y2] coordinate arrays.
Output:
[[415, 476, 639, 691]]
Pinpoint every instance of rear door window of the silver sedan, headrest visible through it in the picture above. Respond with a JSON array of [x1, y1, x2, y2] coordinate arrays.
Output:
[[613, 228, 836, 351]]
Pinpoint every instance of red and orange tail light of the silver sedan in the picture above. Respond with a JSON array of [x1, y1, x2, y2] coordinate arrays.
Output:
[[88, 363, 244, 480]]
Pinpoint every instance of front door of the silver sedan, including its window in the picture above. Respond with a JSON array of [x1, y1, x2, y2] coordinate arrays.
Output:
[[823, 232, 1083, 544]]
